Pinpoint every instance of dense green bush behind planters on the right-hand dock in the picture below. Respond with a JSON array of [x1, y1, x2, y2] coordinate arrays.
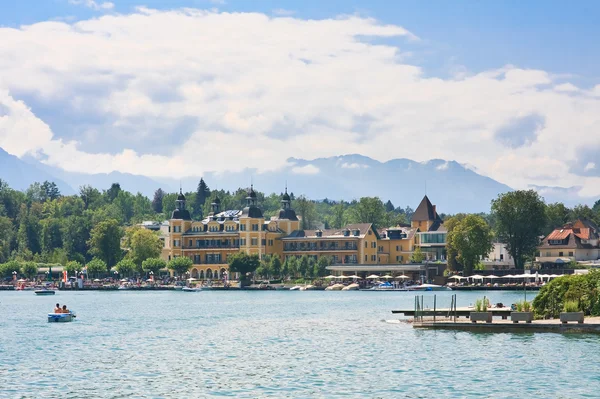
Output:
[[533, 270, 600, 318]]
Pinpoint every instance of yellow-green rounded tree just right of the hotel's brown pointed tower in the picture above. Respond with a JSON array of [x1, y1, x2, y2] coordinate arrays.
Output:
[[447, 215, 493, 274]]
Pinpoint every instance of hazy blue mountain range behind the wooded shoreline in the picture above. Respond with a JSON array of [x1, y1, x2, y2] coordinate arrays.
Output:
[[0, 148, 592, 214]]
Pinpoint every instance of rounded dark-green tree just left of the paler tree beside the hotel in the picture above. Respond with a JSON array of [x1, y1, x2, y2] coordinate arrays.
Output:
[[88, 219, 123, 266]]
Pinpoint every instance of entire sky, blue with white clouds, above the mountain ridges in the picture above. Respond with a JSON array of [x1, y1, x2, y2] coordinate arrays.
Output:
[[0, 0, 600, 198]]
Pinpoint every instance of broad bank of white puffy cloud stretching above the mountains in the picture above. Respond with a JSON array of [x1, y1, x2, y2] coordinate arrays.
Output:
[[0, 7, 600, 194]]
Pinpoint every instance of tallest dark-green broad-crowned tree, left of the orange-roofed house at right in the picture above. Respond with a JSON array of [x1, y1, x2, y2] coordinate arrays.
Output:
[[492, 190, 546, 269]]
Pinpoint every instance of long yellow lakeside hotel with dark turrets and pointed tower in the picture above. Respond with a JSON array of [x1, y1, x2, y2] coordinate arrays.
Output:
[[163, 187, 445, 279]]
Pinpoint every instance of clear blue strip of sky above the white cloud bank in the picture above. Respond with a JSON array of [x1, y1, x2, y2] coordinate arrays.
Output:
[[0, 0, 600, 85]]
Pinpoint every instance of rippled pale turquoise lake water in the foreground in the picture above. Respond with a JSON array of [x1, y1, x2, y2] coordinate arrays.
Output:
[[0, 291, 600, 398]]
